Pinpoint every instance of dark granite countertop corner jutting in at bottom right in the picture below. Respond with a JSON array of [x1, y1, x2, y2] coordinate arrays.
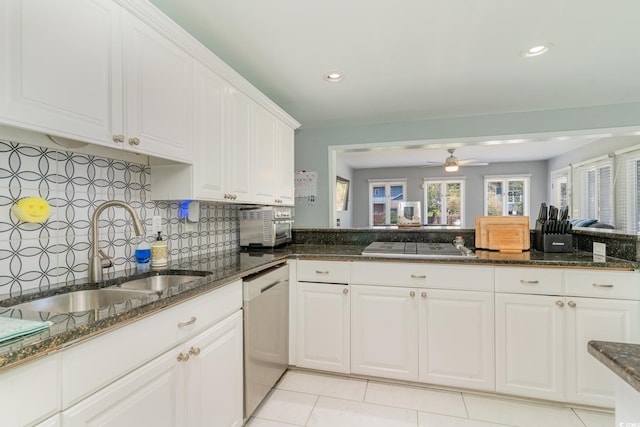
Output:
[[587, 341, 640, 392]]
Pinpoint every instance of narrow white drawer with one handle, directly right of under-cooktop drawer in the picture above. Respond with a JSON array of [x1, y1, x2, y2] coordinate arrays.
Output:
[[495, 267, 563, 295]]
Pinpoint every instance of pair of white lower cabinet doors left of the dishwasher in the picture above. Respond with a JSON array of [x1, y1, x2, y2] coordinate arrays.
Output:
[[62, 311, 242, 427]]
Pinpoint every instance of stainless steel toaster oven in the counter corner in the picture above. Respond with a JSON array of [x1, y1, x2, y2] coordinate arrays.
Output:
[[240, 206, 293, 248]]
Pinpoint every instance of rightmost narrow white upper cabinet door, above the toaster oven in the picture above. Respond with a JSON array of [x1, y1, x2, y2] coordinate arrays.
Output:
[[275, 121, 295, 206]]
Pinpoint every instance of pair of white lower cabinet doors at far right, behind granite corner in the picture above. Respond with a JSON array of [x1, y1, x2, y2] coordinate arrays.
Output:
[[496, 294, 640, 407]]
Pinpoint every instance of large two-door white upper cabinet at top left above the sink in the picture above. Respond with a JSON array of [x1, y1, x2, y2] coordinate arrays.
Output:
[[0, 0, 193, 162]]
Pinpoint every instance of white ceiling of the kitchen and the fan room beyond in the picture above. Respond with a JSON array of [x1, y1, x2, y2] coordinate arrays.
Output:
[[150, 0, 640, 167]]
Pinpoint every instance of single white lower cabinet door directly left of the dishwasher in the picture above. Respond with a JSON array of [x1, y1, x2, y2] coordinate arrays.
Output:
[[188, 311, 243, 427]]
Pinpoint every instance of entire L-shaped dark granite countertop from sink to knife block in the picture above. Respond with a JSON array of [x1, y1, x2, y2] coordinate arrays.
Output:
[[0, 244, 636, 369]]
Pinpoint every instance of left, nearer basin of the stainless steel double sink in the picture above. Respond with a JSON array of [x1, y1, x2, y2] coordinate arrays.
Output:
[[11, 289, 154, 313]]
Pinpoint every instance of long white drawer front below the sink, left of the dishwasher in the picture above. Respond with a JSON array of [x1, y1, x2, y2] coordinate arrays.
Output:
[[62, 280, 242, 409]]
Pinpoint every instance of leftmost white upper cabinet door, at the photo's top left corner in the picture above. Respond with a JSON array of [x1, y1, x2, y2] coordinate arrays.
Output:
[[0, 0, 120, 146]]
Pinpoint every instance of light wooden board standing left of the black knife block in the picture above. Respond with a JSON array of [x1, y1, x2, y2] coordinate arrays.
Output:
[[476, 216, 531, 253]]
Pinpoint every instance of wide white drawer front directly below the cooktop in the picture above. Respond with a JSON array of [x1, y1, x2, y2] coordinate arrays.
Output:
[[351, 261, 493, 291]]
